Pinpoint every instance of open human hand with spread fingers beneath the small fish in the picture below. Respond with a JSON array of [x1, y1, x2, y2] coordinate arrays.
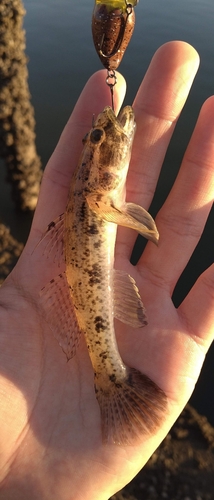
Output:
[[0, 42, 214, 500]]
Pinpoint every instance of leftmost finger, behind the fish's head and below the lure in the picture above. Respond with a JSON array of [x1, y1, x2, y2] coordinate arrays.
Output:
[[30, 70, 126, 237]]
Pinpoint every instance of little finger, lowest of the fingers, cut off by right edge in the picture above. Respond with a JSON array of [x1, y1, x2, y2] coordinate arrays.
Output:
[[178, 264, 214, 350]]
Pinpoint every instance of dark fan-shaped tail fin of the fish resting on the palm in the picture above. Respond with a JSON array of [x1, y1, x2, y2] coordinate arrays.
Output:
[[95, 368, 167, 445]]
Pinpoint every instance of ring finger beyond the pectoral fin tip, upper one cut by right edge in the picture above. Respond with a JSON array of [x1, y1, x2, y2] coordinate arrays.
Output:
[[140, 97, 214, 293]]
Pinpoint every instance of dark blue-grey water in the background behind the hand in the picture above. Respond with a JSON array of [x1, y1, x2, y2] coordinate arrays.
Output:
[[0, 0, 214, 424]]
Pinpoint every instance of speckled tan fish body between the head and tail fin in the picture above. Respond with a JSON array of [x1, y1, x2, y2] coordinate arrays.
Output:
[[65, 194, 124, 382]]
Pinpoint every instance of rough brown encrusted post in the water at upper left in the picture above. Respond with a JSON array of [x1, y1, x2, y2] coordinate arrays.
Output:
[[0, 0, 42, 210]]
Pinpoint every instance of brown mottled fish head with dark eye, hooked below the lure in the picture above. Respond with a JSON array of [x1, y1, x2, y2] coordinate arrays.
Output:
[[83, 106, 136, 194]]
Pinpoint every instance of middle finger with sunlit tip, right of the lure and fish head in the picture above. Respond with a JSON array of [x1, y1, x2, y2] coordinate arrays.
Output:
[[118, 42, 199, 256]]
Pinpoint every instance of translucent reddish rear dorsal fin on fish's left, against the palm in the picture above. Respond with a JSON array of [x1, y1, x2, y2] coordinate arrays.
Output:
[[40, 273, 81, 360]]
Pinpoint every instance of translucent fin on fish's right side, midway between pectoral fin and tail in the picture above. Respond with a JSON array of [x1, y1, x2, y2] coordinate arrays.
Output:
[[114, 270, 147, 328]]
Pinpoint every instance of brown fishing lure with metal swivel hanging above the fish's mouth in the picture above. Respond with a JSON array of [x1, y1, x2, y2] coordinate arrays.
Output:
[[92, 0, 138, 108]]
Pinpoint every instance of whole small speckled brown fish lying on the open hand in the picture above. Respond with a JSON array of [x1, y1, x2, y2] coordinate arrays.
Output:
[[41, 106, 167, 445]]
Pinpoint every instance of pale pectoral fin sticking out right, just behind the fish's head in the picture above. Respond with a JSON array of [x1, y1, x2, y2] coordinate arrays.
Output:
[[86, 194, 159, 245]]
